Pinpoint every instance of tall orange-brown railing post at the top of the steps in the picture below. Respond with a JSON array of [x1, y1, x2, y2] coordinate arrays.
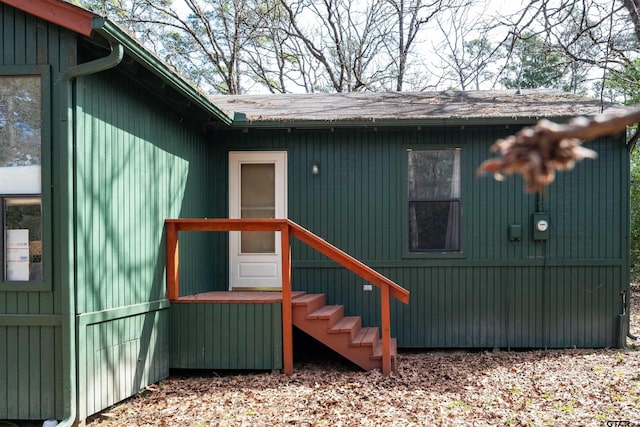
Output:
[[280, 224, 293, 375]]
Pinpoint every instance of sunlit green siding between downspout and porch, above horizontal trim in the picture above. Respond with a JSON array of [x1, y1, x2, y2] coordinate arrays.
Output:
[[76, 73, 188, 313]]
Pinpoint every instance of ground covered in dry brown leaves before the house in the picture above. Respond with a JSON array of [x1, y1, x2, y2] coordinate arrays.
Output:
[[88, 290, 640, 427]]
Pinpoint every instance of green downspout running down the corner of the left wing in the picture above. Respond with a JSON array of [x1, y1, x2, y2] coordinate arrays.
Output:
[[59, 30, 124, 427]]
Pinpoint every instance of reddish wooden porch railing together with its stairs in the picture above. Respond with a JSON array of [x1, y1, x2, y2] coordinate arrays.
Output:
[[165, 218, 409, 375]]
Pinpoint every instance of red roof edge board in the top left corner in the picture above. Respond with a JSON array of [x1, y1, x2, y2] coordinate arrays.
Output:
[[0, 0, 98, 37]]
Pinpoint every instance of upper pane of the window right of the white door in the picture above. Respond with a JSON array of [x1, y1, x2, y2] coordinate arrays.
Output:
[[408, 150, 460, 200]]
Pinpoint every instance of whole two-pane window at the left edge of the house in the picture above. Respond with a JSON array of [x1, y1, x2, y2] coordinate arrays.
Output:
[[0, 75, 43, 282]]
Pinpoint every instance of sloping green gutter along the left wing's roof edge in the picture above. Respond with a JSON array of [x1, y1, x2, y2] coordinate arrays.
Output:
[[93, 18, 233, 125]]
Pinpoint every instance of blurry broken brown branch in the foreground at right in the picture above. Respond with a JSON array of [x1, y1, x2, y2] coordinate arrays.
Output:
[[478, 109, 640, 192]]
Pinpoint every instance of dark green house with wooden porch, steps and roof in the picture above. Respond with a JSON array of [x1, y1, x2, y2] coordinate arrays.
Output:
[[0, 0, 629, 424]]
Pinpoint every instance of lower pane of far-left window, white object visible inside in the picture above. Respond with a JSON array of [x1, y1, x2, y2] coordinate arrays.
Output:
[[4, 197, 42, 281]]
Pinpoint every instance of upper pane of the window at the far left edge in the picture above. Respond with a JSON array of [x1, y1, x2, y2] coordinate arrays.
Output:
[[0, 76, 42, 194]]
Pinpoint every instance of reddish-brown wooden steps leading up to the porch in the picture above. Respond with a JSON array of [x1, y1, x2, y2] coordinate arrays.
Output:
[[291, 293, 397, 371]]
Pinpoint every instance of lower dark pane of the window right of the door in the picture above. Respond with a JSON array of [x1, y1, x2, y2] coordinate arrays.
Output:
[[409, 201, 460, 251]]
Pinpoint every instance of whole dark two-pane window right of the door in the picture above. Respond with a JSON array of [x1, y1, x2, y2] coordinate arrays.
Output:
[[407, 148, 461, 252]]
